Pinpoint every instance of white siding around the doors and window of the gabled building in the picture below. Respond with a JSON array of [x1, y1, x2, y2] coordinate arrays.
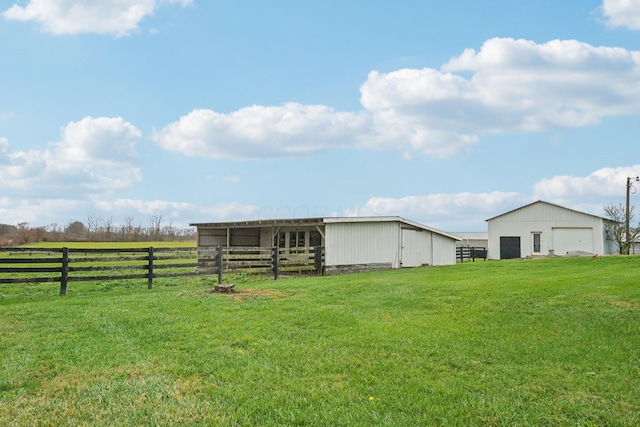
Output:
[[488, 202, 609, 259]]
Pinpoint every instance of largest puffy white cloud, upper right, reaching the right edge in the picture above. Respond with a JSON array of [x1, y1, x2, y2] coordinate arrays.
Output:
[[361, 38, 640, 155]]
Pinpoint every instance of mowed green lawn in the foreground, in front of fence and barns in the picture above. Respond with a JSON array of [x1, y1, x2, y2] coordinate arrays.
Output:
[[0, 257, 640, 426]]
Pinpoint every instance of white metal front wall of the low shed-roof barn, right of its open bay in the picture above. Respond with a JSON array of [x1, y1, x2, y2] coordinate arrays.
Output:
[[325, 222, 400, 268]]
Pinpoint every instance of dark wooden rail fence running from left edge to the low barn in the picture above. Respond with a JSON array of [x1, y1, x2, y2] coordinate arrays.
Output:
[[0, 247, 324, 295]]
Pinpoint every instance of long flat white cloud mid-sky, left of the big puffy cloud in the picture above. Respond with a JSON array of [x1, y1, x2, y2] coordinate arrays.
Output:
[[154, 103, 367, 159]]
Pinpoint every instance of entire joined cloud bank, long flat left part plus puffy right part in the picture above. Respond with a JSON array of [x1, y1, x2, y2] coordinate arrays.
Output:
[[154, 38, 640, 159]]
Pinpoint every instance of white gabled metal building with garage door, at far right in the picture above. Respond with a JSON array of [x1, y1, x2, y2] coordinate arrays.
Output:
[[487, 201, 615, 259]]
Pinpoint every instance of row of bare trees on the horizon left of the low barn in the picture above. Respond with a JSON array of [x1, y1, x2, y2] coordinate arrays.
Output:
[[0, 211, 196, 246]]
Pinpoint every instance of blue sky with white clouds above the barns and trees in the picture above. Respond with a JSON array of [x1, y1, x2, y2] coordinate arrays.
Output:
[[0, 0, 640, 232]]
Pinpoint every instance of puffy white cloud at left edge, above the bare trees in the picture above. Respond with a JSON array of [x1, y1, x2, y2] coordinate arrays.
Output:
[[0, 117, 142, 198]]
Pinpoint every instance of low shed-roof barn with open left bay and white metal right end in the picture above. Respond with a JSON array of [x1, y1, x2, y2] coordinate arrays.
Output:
[[190, 216, 459, 273]]
